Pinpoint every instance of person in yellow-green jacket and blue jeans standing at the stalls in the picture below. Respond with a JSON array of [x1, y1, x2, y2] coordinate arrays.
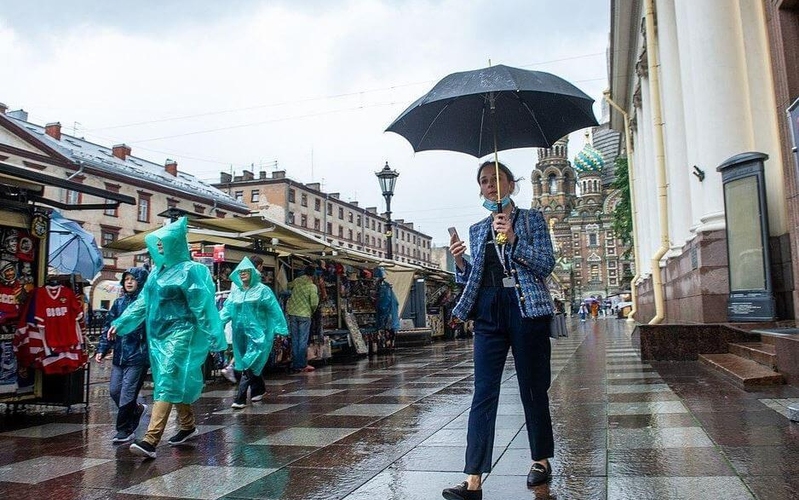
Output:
[[286, 266, 319, 373]]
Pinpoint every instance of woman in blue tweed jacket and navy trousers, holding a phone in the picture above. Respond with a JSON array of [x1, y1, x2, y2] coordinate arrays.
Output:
[[443, 161, 555, 500]]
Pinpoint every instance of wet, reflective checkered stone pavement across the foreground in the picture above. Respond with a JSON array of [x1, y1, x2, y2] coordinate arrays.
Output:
[[0, 319, 799, 500]]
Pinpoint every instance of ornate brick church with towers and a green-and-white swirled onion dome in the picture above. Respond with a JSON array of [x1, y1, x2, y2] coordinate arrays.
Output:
[[531, 131, 633, 305]]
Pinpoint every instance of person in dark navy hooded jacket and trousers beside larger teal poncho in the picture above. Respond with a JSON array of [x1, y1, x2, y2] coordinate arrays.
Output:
[[95, 267, 150, 444]]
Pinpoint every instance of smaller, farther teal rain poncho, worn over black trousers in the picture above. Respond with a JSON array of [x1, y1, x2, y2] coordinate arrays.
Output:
[[220, 257, 288, 375]]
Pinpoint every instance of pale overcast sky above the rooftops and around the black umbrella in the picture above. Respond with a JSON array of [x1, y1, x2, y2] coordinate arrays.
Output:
[[0, 0, 609, 245]]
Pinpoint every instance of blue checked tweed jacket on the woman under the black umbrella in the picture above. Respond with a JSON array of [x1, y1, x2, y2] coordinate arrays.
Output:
[[452, 209, 555, 321]]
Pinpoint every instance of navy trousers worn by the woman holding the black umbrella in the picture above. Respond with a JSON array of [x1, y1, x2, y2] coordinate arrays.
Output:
[[463, 288, 555, 474]]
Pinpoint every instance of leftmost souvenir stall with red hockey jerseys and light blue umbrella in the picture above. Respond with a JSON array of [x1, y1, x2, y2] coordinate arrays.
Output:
[[0, 168, 134, 411]]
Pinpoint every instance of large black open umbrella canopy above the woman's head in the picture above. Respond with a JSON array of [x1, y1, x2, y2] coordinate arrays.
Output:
[[386, 65, 597, 158]]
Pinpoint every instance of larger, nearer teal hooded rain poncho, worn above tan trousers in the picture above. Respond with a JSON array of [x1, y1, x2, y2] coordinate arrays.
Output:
[[112, 217, 227, 404]]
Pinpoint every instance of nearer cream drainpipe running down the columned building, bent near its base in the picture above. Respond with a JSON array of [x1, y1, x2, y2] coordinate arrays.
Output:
[[645, 0, 671, 325]]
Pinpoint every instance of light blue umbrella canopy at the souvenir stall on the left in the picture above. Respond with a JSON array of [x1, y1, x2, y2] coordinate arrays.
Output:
[[48, 212, 103, 280]]
